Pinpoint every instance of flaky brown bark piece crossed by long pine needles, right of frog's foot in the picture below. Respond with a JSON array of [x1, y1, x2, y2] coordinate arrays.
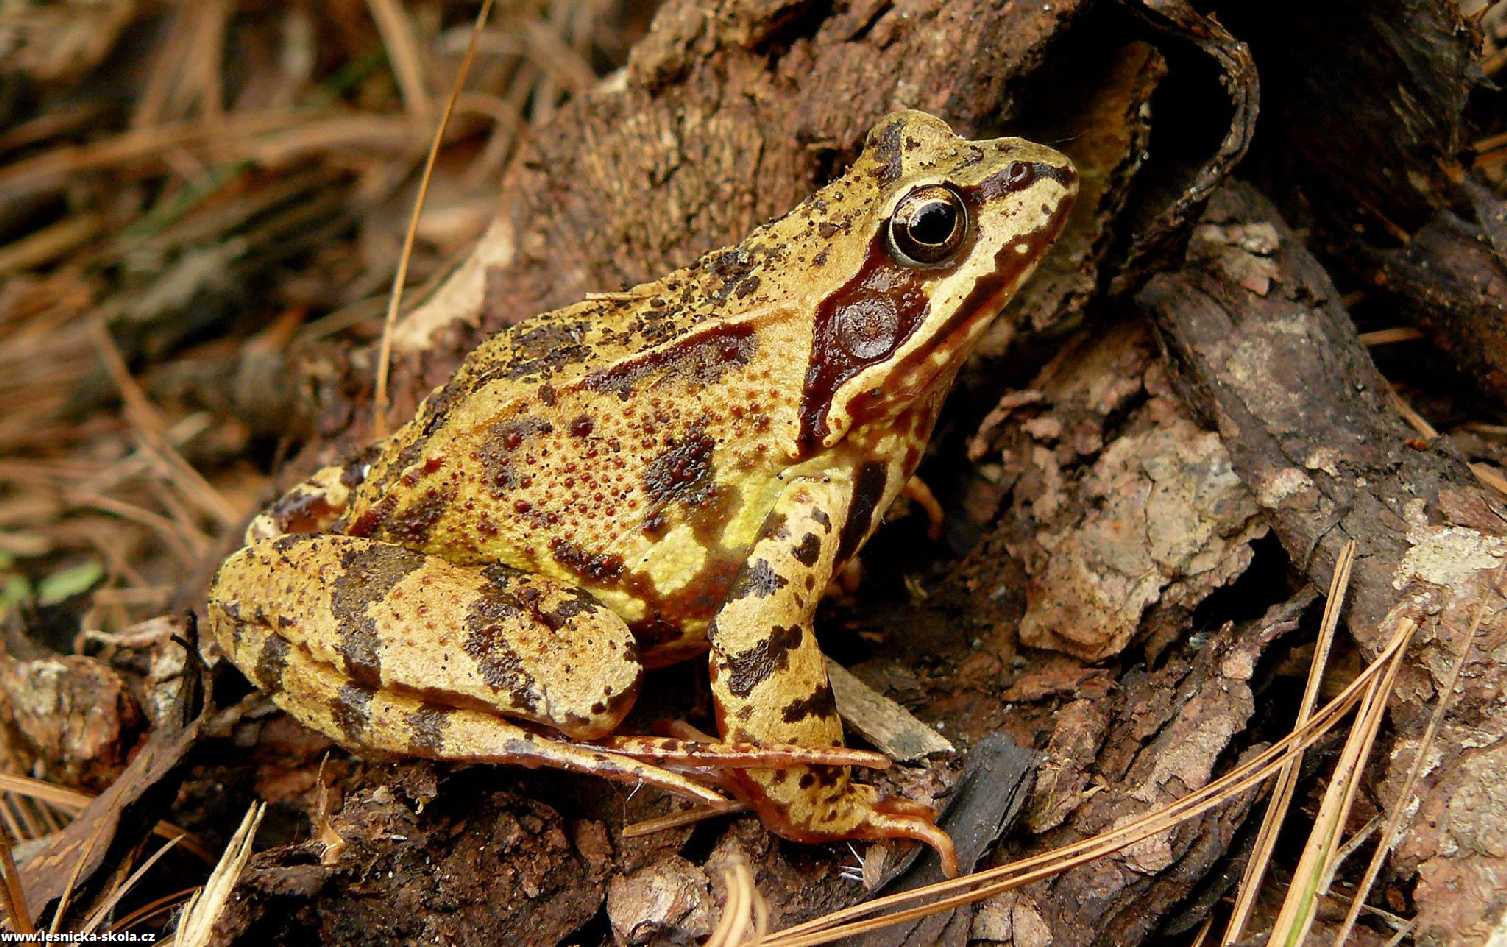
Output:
[[1010, 591, 1313, 947]]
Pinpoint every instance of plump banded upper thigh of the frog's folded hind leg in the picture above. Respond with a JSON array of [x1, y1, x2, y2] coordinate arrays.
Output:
[[211, 535, 642, 739]]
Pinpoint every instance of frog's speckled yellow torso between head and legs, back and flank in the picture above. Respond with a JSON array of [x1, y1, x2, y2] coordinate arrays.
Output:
[[342, 243, 809, 651]]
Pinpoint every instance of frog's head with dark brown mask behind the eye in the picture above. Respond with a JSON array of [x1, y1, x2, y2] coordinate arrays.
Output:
[[800, 112, 1078, 452]]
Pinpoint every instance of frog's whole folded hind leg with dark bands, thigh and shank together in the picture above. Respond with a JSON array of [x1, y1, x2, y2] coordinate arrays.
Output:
[[209, 534, 723, 804]]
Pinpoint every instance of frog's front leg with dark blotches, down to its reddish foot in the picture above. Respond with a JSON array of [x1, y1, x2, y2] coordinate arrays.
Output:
[[708, 478, 957, 876]]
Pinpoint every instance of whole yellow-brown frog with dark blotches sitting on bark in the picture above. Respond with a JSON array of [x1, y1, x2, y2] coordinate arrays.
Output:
[[209, 112, 1076, 872]]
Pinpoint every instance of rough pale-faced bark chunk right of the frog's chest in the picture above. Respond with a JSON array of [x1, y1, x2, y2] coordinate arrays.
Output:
[[976, 323, 1267, 663]]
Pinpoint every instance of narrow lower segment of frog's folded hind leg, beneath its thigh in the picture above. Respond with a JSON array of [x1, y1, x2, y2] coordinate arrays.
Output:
[[220, 594, 726, 805]]
